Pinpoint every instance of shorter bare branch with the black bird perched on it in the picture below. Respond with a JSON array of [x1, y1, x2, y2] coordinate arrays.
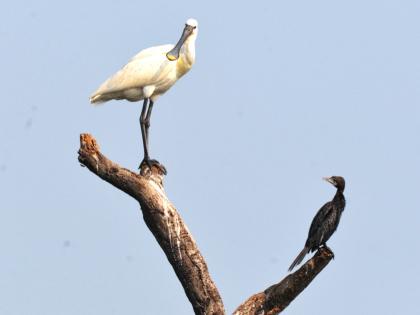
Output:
[[233, 248, 334, 315]]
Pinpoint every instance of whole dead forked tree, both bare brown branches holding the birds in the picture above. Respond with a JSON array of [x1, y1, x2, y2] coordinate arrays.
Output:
[[79, 134, 333, 315]]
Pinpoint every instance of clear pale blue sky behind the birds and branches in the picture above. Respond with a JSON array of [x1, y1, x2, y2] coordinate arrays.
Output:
[[0, 0, 420, 315]]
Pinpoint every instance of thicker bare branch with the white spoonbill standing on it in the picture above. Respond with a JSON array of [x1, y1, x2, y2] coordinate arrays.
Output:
[[79, 134, 225, 315]]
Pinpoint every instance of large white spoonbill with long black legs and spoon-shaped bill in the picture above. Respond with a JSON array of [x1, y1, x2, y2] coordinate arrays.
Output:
[[90, 19, 198, 173]]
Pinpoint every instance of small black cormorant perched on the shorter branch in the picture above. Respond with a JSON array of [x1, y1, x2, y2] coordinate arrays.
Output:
[[289, 176, 346, 271]]
